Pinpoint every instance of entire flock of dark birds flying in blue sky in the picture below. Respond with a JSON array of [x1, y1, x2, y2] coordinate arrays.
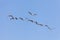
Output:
[[9, 11, 52, 30]]
